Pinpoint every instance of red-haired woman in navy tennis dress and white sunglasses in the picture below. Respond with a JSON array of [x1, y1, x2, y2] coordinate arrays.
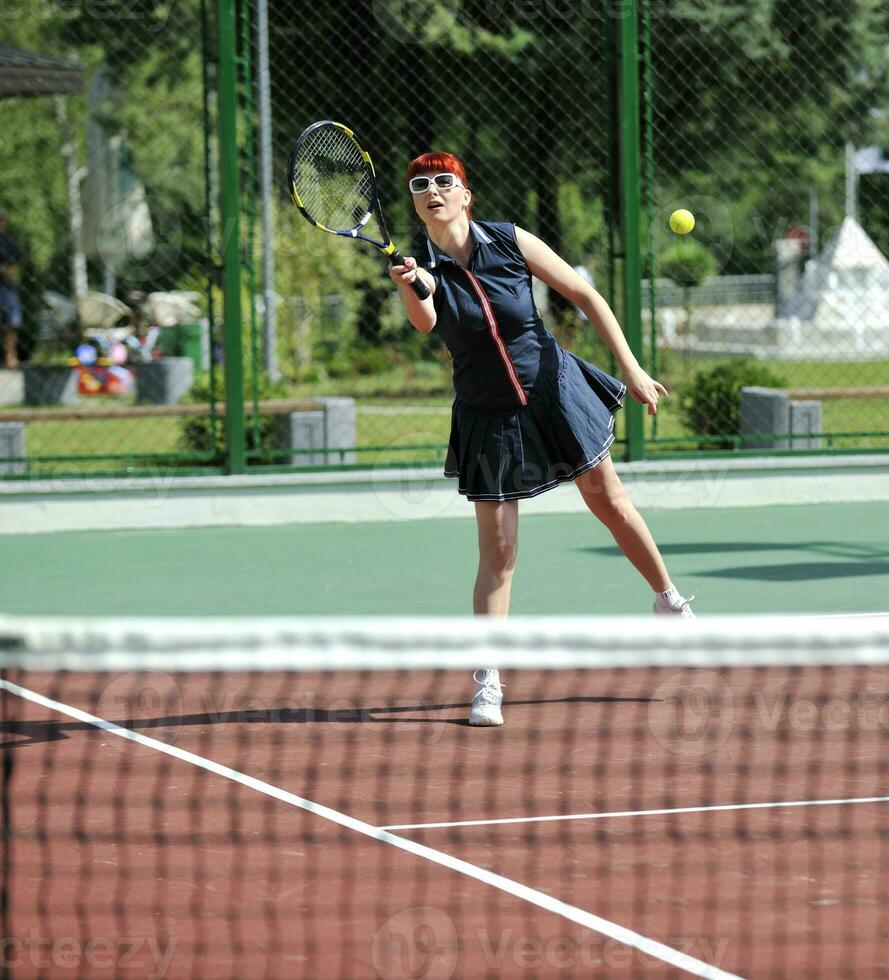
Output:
[[389, 153, 694, 725]]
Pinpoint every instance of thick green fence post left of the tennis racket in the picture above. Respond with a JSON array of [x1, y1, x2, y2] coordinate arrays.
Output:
[[217, 0, 246, 473]]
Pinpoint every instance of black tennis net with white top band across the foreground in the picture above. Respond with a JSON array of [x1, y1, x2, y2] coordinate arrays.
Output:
[[0, 617, 889, 980]]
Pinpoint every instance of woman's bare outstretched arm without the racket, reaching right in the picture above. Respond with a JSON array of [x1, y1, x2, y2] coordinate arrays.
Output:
[[516, 226, 668, 415]]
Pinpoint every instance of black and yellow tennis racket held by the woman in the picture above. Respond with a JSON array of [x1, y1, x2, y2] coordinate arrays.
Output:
[[290, 119, 430, 299]]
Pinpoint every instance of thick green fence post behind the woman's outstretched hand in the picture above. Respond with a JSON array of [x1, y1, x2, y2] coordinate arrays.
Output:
[[618, 0, 645, 460]]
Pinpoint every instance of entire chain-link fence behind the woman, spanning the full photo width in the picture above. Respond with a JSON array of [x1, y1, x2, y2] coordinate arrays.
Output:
[[0, 0, 889, 476]]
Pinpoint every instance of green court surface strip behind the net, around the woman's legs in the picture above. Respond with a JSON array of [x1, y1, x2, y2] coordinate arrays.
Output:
[[0, 503, 889, 616]]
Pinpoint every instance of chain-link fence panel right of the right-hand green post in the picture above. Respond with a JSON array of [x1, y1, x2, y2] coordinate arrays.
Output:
[[641, 0, 889, 451]]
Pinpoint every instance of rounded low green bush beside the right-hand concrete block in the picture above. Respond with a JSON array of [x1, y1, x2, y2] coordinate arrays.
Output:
[[679, 359, 786, 449]]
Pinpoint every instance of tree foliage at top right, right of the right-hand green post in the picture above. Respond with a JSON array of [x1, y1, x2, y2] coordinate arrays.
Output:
[[651, 0, 889, 274]]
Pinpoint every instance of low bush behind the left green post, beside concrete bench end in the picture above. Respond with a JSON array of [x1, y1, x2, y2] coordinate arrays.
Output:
[[180, 368, 292, 466]]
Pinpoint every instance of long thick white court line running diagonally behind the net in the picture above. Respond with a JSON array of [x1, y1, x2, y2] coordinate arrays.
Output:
[[0, 678, 740, 980]]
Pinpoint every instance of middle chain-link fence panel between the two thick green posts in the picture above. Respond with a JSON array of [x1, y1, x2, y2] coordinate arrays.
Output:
[[241, 0, 620, 466]]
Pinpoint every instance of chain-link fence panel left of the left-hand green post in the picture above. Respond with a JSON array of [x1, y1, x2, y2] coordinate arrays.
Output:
[[0, 0, 221, 476]]
